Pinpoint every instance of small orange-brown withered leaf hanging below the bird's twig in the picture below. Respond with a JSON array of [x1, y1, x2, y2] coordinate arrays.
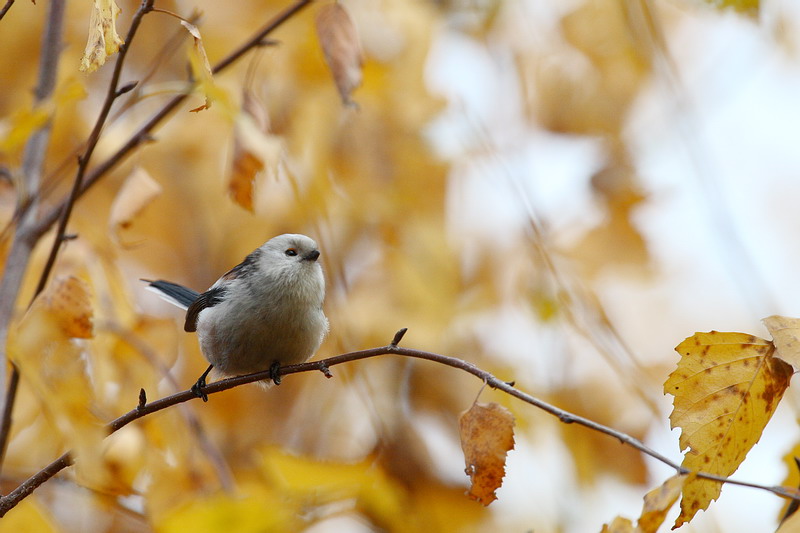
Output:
[[459, 403, 514, 505]]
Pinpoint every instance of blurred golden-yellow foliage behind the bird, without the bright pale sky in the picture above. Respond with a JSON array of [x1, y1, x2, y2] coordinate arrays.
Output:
[[0, 0, 792, 533]]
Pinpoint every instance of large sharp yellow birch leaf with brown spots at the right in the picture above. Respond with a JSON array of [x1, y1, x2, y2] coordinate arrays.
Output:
[[664, 331, 792, 528]]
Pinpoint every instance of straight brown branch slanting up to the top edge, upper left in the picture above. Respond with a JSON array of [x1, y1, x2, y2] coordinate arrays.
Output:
[[25, 0, 313, 242]]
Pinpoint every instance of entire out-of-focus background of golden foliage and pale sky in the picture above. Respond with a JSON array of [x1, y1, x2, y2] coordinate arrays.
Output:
[[0, 0, 800, 533]]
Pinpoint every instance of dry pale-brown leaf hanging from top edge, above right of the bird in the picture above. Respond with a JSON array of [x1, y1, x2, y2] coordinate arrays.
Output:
[[317, 3, 363, 105]]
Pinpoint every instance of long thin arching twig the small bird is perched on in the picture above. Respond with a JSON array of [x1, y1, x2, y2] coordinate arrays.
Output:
[[0, 328, 800, 517]]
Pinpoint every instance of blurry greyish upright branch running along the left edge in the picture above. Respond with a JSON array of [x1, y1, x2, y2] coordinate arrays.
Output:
[[0, 0, 66, 474]]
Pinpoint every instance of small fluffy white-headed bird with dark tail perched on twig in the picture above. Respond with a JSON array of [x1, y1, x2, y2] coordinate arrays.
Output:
[[143, 234, 328, 401]]
